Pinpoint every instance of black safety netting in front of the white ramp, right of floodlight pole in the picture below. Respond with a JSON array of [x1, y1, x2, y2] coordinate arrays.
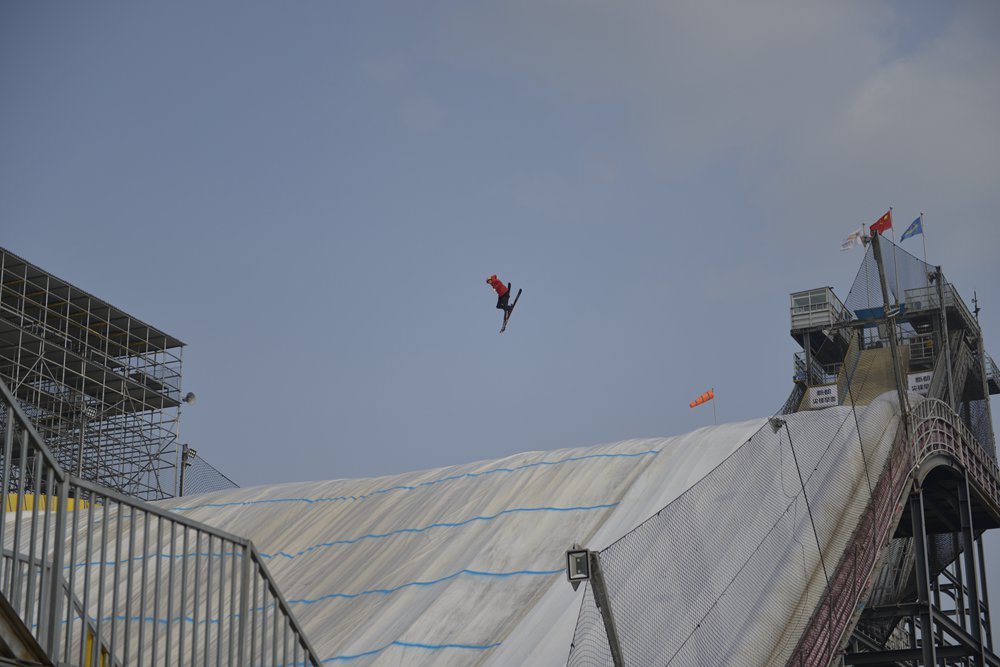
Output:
[[568, 344, 898, 667]]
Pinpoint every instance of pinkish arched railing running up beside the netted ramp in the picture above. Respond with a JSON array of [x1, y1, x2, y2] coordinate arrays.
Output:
[[787, 399, 1000, 667]]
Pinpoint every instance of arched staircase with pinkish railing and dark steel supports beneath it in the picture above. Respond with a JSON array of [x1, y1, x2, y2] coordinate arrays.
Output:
[[788, 399, 1000, 667]]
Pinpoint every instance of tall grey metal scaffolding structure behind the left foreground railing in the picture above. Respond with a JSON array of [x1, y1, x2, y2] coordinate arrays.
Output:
[[0, 248, 184, 500]]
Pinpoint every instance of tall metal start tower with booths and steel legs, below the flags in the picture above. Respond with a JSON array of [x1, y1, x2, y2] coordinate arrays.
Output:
[[790, 236, 1000, 667]]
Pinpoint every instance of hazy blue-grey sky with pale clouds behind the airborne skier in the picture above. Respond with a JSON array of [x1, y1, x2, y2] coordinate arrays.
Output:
[[0, 0, 1000, 648]]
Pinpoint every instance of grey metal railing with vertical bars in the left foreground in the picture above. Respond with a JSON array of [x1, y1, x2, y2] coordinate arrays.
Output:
[[0, 382, 320, 667]]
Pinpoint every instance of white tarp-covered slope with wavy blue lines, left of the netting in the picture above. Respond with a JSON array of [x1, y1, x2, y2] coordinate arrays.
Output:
[[162, 396, 904, 665]]
